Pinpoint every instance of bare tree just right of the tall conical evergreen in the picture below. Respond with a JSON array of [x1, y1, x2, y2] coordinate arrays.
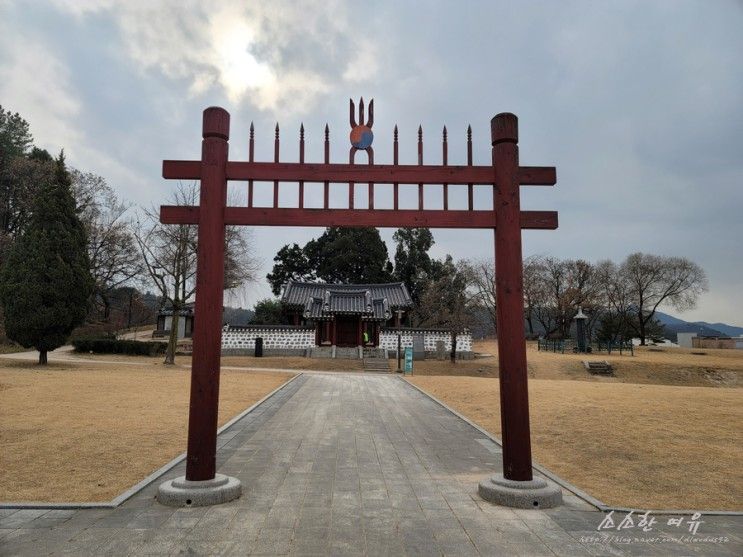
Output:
[[70, 169, 144, 320]]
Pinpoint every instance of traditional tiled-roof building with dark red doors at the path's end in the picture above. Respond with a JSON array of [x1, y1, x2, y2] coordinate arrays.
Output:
[[281, 281, 413, 347]]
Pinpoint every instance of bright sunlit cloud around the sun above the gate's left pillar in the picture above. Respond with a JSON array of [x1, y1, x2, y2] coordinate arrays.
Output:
[[48, 0, 377, 112]]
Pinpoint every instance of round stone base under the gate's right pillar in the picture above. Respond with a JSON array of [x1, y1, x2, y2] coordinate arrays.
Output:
[[478, 474, 562, 509]]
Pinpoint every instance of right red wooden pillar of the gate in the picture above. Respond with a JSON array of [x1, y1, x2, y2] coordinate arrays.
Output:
[[490, 113, 532, 481]]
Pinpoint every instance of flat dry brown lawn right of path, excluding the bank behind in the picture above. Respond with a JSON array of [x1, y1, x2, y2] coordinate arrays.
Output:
[[410, 377, 743, 510]]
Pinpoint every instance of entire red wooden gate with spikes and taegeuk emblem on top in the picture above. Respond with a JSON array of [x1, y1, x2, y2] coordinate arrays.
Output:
[[160, 99, 557, 481]]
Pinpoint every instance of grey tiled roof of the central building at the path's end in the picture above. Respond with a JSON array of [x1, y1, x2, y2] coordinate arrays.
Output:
[[281, 282, 412, 321]]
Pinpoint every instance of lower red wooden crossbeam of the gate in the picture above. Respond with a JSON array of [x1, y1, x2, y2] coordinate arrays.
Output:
[[160, 205, 557, 230]]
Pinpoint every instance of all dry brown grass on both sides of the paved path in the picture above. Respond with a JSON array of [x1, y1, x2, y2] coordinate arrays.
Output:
[[0, 342, 743, 510]]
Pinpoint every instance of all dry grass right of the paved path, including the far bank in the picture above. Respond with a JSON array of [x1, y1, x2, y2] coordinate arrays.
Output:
[[411, 343, 743, 510]]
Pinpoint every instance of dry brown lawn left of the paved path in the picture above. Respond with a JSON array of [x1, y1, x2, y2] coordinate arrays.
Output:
[[0, 360, 292, 502]]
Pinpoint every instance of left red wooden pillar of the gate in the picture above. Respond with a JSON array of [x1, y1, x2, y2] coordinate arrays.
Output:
[[186, 107, 230, 481]]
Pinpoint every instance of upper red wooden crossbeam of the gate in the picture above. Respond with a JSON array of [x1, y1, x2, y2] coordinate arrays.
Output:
[[163, 160, 557, 186]]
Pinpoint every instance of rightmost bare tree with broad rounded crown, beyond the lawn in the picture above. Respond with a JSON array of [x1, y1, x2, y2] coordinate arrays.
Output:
[[620, 252, 709, 346]]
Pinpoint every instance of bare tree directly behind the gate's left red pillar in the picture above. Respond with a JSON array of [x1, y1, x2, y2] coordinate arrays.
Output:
[[135, 183, 259, 364]]
